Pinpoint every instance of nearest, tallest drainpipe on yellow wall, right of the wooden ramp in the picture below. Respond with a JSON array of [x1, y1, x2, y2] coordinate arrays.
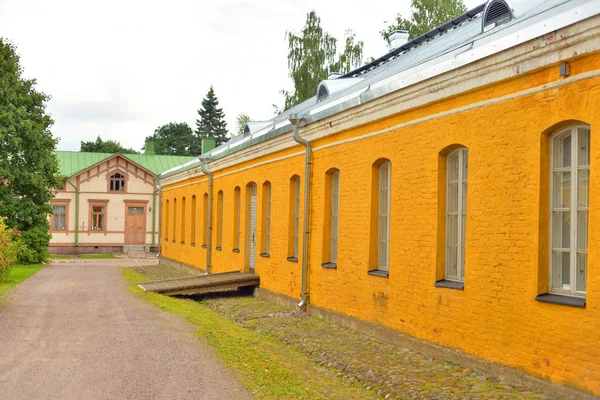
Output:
[[289, 113, 312, 311]]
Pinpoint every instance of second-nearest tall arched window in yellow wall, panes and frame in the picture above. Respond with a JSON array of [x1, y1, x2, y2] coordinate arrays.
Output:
[[445, 147, 469, 282]]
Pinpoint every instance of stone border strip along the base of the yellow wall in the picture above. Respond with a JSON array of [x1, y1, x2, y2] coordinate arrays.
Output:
[[255, 288, 597, 400]]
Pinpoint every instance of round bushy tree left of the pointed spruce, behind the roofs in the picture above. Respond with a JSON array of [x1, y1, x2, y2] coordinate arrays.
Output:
[[146, 122, 193, 156]]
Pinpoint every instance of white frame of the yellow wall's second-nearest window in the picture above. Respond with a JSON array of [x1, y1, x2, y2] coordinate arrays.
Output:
[[445, 147, 469, 282]]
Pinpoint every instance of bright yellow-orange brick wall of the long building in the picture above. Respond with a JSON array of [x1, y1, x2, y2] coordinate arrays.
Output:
[[162, 54, 600, 394]]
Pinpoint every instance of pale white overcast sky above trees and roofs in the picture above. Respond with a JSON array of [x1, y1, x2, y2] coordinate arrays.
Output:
[[0, 0, 483, 150]]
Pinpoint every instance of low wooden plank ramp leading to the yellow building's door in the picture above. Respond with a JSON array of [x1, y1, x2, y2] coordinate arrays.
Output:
[[138, 272, 260, 296]]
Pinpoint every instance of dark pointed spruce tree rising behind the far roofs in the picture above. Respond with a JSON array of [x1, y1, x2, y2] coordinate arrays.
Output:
[[192, 86, 228, 154]]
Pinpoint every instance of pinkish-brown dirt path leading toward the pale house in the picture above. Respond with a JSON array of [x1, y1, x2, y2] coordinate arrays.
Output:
[[0, 262, 251, 400]]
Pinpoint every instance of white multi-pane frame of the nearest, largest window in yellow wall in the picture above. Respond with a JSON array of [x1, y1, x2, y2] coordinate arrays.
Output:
[[548, 125, 591, 298]]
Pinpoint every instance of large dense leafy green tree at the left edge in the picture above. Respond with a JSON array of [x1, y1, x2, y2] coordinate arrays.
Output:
[[0, 38, 60, 262]]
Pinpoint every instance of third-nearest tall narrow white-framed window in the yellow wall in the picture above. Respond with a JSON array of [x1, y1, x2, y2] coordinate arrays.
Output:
[[377, 161, 392, 272]]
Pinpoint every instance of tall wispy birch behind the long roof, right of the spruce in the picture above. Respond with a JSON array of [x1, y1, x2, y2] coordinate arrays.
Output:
[[276, 11, 363, 112]]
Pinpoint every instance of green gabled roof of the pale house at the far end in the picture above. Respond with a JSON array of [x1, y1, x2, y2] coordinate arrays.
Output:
[[55, 151, 196, 177]]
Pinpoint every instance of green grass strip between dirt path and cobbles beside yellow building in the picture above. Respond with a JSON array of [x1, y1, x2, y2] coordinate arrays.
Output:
[[123, 268, 373, 399]]
